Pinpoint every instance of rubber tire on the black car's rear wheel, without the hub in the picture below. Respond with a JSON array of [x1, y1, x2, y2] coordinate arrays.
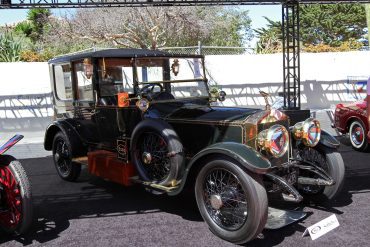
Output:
[[53, 131, 81, 182]]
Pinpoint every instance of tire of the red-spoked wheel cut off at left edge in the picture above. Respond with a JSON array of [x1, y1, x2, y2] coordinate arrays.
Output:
[[0, 155, 33, 235]]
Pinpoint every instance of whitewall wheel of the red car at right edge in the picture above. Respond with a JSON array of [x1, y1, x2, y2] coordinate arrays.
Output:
[[349, 120, 369, 151]]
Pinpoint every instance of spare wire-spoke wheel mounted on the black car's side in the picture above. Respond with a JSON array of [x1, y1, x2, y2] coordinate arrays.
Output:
[[131, 119, 184, 186]]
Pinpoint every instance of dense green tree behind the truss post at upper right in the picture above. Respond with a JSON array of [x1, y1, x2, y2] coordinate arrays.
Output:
[[255, 4, 366, 52]]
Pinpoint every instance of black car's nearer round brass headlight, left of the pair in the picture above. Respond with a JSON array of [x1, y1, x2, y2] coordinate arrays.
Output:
[[257, 124, 289, 158]]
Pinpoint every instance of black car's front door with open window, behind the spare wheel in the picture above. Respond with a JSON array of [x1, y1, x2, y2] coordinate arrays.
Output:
[[95, 58, 141, 150]]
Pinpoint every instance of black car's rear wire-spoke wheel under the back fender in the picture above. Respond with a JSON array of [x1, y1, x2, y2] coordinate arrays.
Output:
[[53, 132, 81, 181]]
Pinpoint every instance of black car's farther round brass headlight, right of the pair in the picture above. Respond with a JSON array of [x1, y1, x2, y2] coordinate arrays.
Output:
[[293, 118, 321, 147]]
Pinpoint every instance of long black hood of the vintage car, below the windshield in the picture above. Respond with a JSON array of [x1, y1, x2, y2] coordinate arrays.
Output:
[[146, 102, 261, 123]]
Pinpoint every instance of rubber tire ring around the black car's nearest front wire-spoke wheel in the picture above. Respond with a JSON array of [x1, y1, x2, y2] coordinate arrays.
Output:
[[195, 157, 268, 244]]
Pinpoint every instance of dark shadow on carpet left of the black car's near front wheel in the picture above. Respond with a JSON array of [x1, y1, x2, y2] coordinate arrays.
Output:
[[0, 163, 202, 246]]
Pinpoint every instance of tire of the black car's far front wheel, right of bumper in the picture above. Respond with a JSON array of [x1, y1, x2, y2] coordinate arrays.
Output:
[[300, 146, 345, 202]]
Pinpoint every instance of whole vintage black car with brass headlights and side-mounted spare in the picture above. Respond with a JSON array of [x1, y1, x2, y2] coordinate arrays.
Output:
[[44, 49, 344, 243]]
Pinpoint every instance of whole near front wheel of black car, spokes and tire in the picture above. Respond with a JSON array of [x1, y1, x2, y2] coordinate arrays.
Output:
[[195, 157, 268, 244]]
